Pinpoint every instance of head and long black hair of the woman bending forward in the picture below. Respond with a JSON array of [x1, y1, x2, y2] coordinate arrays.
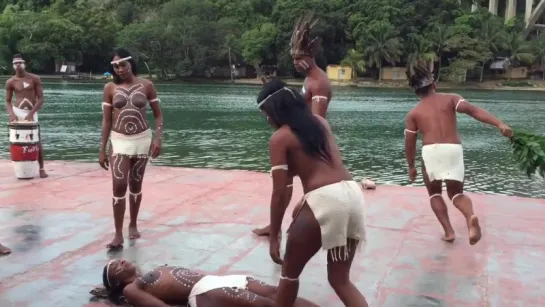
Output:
[[257, 79, 331, 163]]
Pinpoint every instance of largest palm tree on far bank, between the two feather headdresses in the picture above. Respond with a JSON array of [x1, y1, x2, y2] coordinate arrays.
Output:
[[363, 21, 403, 80]]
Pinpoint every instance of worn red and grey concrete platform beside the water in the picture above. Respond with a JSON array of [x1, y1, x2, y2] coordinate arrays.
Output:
[[0, 161, 545, 307]]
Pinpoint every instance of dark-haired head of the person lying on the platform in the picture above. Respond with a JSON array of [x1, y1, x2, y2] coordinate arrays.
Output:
[[91, 260, 137, 305]]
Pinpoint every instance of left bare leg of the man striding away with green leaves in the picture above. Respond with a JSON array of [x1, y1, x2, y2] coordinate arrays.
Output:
[[422, 165, 456, 243]]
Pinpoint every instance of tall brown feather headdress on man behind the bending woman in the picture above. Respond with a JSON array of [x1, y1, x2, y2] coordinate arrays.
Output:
[[290, 13, 321, 57]]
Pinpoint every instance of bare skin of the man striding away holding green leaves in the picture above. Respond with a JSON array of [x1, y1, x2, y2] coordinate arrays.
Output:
[[405, 84, 513, 245]]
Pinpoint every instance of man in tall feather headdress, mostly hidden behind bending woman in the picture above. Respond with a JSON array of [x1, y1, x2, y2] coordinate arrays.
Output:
[[252, 14, 376, 236]]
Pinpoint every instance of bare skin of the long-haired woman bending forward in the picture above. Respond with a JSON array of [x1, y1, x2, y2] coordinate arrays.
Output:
[[269, 115, 368, 307]]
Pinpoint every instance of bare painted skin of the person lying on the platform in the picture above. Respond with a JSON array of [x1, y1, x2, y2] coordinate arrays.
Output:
[[108, 260, 318, 307]]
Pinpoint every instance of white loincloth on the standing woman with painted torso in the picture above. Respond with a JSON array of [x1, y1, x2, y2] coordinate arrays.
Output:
[[110, 129, 152, 158]]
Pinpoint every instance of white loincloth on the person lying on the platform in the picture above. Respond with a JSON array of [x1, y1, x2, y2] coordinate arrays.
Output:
[[188, 275, 248, 307]]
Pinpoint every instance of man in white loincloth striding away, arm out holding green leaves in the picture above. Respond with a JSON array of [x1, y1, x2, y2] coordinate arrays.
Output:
[[405, 63, 513, 245]]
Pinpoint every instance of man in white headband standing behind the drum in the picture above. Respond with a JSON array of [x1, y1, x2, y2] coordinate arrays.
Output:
[[6, 54, 48, 178]]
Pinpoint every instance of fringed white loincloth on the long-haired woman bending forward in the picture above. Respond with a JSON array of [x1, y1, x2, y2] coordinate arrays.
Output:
[[292, 180, 366, 260]]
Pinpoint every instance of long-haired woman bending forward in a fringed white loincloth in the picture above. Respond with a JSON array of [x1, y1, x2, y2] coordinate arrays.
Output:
[[257, 80, 368, 307]]
